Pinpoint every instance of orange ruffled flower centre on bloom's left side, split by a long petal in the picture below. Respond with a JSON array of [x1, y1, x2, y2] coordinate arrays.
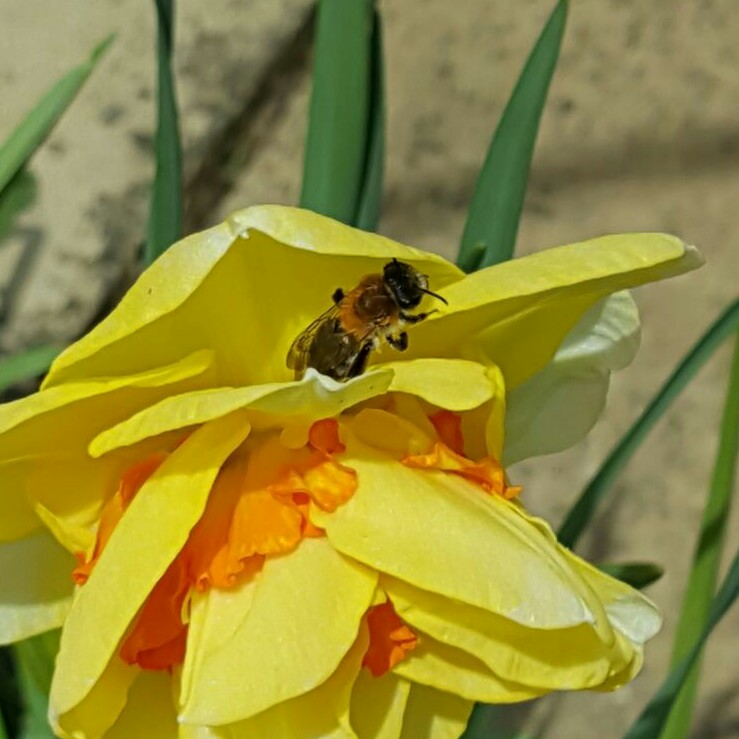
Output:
[[72, 419, 357, 670]]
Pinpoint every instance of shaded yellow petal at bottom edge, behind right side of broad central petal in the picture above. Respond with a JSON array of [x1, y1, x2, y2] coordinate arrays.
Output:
[[220, 629, 369, 739]]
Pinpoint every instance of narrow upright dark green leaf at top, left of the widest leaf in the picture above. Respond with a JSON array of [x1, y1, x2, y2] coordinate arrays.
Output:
[[144, 0, 182, 264]]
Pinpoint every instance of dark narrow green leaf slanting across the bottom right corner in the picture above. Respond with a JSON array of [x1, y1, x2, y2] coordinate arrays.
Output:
[[624, 552, 739, 739]]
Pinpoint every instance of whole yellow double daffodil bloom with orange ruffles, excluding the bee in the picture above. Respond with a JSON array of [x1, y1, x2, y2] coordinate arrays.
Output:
[[0, 206, 700, 739]]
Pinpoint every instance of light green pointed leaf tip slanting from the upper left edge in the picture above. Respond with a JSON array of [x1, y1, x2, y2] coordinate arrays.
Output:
[[0, 36, 113, 197]]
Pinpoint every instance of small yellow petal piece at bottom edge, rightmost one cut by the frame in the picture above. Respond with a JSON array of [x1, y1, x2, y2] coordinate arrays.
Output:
[[400, 684, 474, 739]]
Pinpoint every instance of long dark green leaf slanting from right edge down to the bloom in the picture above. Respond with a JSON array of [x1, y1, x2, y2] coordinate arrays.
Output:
[[557, 300, 739, 549]]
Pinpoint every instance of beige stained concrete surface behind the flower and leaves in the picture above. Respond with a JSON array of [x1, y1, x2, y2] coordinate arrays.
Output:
[[0, 0, 739, 739]]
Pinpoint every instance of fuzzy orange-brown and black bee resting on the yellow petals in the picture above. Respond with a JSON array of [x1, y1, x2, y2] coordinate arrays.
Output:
[[287, 259, 448, 380]]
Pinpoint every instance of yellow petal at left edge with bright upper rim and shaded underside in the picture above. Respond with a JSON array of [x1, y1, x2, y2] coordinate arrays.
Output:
[[0, 351, 213, 540]]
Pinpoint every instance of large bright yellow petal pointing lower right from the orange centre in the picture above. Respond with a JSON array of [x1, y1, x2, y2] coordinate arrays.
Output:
[[311, 430, 608, 630]]
